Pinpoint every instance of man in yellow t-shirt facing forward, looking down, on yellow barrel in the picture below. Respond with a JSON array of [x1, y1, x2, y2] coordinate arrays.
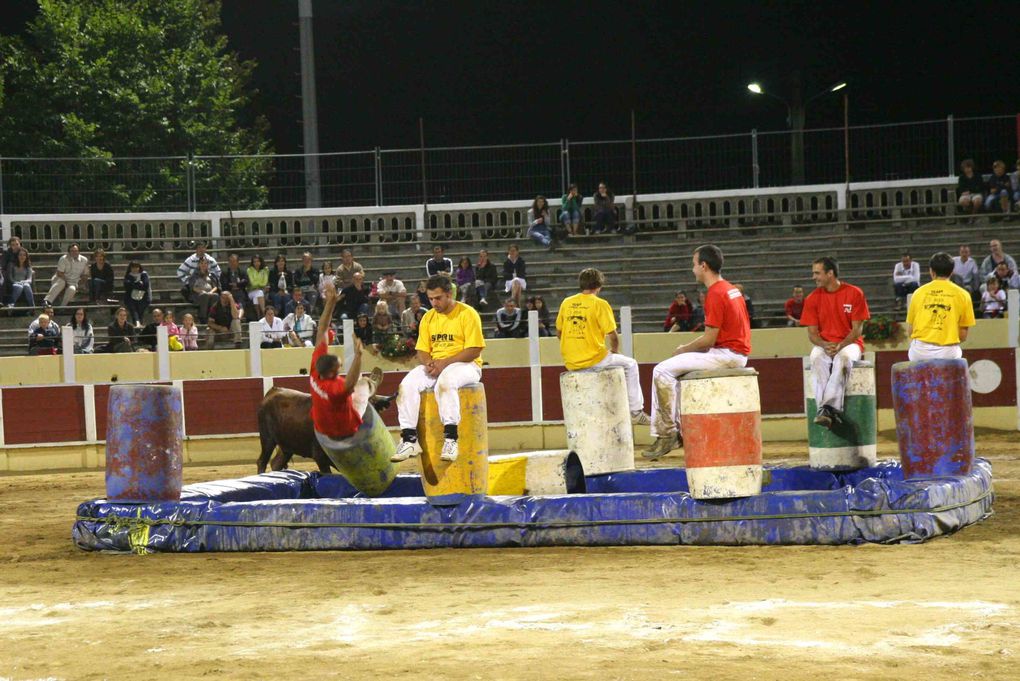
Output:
[[391, 274, 486, 462]]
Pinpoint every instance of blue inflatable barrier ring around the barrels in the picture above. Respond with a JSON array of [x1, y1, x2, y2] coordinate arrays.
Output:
[[71, 460, 993, 553]]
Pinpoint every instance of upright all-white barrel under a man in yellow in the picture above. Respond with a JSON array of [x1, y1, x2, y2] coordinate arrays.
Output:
[[560, 367, 634, 475]]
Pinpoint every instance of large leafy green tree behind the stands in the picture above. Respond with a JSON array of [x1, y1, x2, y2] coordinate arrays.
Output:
[[0, 0, 272, 212]]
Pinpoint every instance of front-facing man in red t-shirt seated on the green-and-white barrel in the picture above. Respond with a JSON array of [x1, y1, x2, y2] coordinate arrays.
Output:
[[801, 257, 871, 428]]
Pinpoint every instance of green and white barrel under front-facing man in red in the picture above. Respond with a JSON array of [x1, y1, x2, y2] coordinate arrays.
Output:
[[804, 358, 878, 470]]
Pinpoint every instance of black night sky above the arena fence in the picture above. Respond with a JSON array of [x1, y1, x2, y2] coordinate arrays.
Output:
[[3, 0, 1020, 152]]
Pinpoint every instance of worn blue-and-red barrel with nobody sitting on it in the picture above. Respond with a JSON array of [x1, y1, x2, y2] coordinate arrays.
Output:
[[106, 384, 184, 503]]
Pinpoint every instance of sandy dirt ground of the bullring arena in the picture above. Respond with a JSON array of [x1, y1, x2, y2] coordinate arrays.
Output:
[[0, 434, 1020, 681]]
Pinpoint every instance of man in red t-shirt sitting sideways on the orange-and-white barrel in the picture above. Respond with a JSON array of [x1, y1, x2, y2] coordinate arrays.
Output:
[[642, 245, 751, 459]]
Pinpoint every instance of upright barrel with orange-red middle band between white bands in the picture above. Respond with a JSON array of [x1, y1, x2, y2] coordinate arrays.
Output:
[[679, 369, 762, 499]]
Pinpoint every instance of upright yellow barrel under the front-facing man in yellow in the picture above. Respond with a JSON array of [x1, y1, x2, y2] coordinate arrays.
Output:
[[418, 383, 489, 506]]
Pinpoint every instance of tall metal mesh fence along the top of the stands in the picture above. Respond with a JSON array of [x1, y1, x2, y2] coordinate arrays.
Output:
[[0, 114, 1020, 214]]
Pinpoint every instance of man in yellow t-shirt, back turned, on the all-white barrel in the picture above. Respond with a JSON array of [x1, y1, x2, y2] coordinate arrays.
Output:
[[556, 267, 651, 425]]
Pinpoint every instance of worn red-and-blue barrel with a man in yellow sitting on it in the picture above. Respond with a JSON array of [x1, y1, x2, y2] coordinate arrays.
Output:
[[893, 360, 974, 479]]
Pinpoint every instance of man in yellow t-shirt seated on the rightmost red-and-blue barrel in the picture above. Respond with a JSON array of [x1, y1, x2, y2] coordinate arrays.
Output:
[[907, 253, 974, 362]]
